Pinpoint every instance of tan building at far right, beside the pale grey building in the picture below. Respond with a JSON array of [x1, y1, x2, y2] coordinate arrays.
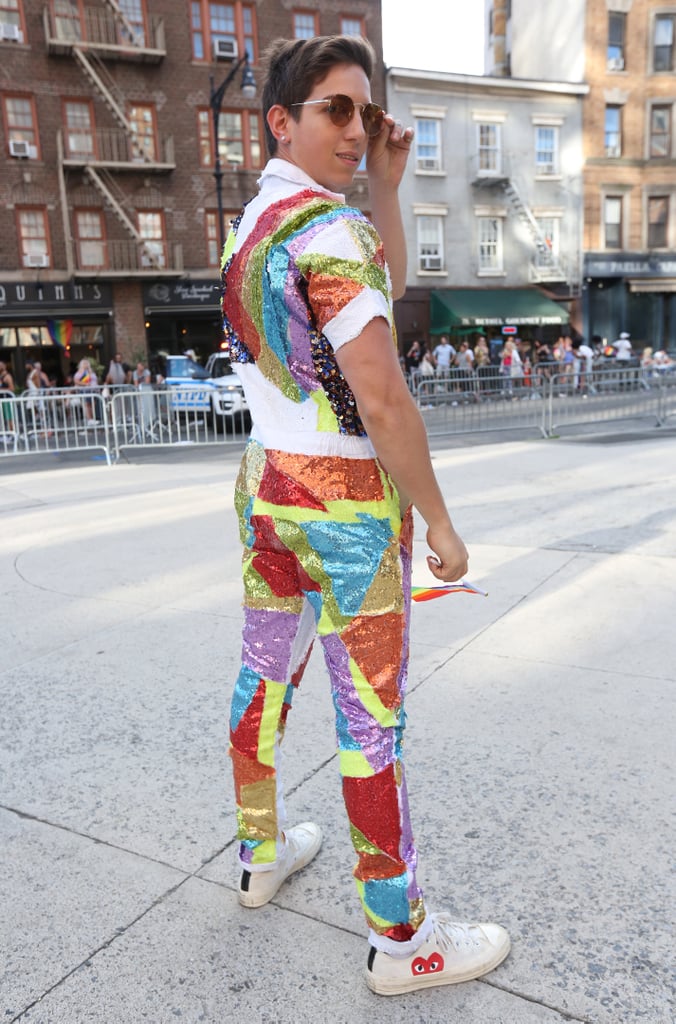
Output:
[[487, 0, 676, 351]]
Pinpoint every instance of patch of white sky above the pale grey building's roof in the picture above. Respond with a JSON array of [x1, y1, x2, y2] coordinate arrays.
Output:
[[382, 0, 483, 75]]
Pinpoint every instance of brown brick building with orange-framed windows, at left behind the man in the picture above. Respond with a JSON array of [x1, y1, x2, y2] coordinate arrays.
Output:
[[0, 0, 384, 384]]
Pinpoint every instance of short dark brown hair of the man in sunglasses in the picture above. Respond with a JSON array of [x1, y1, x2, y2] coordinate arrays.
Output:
[[262, 36, 376, 157]]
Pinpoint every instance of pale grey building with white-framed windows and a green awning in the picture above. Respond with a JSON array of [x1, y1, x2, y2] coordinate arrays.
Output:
[[387, 68, 586, 346]]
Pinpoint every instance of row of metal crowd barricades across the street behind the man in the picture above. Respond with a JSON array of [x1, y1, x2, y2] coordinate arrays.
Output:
[[0, 366, 676, 464]]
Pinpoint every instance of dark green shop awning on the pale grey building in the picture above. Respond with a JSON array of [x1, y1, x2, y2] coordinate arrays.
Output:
[[429, 288, 569, 334]]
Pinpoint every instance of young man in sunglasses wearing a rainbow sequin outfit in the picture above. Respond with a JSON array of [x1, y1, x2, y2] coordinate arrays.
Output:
[[223, 37, 509, 994]]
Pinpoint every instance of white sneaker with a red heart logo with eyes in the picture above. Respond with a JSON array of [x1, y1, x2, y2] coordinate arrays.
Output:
[[366, 913, 510, 995]]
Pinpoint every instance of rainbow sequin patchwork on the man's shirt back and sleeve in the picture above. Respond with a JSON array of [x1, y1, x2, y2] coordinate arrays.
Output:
[[222, 189, 393, 436]]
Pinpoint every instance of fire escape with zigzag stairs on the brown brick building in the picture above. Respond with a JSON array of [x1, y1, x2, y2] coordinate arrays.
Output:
[[44, 0, 182, 278]]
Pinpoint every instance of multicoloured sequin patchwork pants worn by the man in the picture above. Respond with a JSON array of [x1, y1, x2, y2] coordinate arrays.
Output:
[[230, 441, 425, 942]]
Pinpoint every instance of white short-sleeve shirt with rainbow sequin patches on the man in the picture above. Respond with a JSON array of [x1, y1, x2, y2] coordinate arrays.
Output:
[[223, 159, 393, 458]]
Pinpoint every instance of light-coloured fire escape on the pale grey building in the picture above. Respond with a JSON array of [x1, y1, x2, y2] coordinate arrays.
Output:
[[472, 159, 580, 295]]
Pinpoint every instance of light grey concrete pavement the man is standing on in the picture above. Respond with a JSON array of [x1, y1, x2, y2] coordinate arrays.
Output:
[[0, 434, 676, 1024]]
